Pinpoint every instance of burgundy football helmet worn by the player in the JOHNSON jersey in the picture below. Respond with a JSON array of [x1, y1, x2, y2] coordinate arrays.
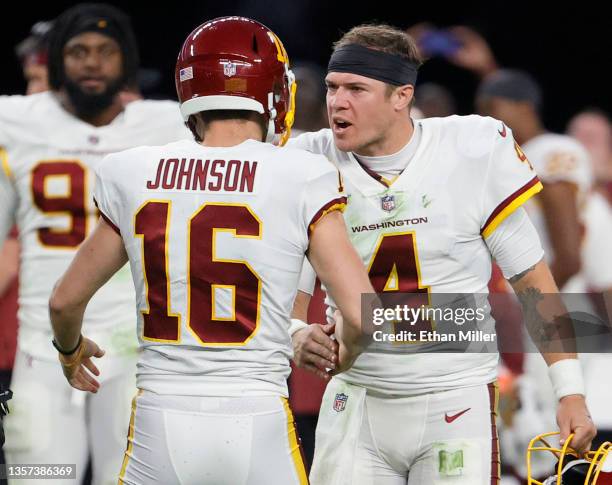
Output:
[[175, 17, 296, 145]]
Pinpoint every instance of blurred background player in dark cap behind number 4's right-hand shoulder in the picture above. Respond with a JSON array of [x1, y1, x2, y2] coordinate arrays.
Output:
[[476, 69, 593, 289]]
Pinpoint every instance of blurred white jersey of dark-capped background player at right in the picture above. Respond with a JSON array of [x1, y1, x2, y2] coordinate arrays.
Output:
[[522, 133, 593, 262]]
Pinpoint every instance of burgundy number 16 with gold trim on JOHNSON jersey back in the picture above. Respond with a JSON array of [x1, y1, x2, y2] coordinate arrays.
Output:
[[135, 200, 262, 346]]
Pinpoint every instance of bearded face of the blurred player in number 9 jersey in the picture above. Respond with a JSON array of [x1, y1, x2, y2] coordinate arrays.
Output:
[[64, 32, 123, 95]]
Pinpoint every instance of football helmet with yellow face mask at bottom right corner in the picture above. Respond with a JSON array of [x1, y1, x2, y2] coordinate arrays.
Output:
[[527, 432, 612, 485]]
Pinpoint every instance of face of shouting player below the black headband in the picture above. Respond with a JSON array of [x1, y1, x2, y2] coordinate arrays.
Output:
[[325, 72, 394, 155]]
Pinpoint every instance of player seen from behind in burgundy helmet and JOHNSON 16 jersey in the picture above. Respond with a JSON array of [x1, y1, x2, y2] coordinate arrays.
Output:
[[50, 17, 373, 485]]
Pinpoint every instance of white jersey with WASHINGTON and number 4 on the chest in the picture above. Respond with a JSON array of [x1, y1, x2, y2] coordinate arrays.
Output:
[[290, 116, 542, 395]]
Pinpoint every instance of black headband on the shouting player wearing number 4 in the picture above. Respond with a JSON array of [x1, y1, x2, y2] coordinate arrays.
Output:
[[327, 44, 418, 86]]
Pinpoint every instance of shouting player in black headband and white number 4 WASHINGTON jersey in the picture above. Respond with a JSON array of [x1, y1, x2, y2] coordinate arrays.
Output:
[[290, 25, 595, 485]]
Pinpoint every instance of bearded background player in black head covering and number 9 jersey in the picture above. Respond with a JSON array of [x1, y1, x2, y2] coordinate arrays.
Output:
[[0, 4, 189, 484]]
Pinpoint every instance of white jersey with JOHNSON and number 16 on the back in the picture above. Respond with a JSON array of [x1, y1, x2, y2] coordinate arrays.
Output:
[[95, 140, 346, 396]]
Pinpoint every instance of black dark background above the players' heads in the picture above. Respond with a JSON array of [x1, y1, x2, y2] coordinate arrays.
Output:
[[0, 0, 612, 131]]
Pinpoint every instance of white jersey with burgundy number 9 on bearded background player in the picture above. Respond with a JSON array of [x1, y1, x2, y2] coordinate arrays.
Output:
[[0, 92, 189, 360]]
